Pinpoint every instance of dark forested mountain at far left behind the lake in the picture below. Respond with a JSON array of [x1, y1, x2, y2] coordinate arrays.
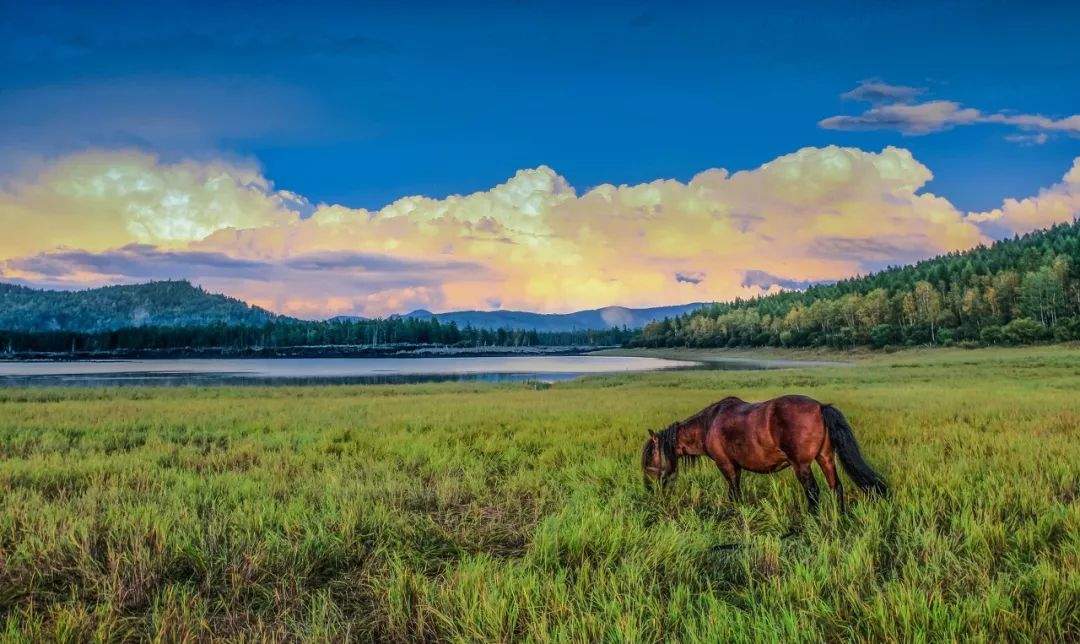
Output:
[[0, 281, 275, 333]]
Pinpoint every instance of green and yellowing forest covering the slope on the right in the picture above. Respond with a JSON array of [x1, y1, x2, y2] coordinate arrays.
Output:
[[629, 222, 1080, 349]]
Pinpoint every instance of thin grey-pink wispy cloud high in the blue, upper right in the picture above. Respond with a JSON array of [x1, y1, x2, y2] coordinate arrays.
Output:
[[818, 81, 1080, 145]]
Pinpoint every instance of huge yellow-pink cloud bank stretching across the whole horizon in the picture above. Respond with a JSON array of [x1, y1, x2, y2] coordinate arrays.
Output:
[[6, 146, 1080, 317]]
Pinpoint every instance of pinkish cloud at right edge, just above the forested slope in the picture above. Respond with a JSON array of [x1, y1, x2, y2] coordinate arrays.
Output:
[[968, 157, 1080, 234]]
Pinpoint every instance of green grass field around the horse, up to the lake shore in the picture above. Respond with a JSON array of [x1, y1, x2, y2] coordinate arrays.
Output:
[[0, 347, 1080, 642]]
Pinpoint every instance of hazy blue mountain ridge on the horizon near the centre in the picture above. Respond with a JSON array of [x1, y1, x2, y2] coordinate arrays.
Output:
[[403, 303, 705, 332]]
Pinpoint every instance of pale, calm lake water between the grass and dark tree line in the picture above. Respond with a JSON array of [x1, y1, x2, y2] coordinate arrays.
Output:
[[0, 355, 701, 387]]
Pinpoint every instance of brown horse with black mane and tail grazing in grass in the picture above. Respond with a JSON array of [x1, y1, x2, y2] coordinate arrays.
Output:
[[642, 395, 888, 512]]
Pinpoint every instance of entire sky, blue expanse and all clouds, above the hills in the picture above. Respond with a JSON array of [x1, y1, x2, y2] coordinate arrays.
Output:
[[0, 0, 1080, 318]]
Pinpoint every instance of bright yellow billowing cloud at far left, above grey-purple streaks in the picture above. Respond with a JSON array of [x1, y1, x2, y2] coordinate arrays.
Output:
[[0, 151, 309, 257]]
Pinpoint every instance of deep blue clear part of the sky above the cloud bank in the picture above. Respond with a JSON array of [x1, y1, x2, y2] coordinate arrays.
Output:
[[0, 2, 1080, 210]]
